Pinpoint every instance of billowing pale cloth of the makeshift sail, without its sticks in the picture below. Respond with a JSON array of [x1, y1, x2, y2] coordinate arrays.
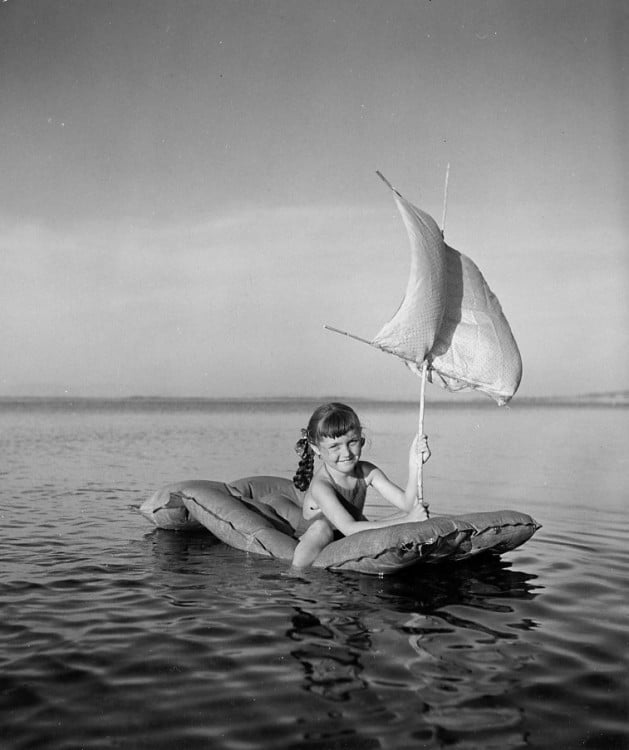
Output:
[[371, 178, 522, 405]]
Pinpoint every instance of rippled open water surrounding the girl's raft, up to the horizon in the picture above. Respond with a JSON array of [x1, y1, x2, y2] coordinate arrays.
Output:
[[0, 401, 629, 750]]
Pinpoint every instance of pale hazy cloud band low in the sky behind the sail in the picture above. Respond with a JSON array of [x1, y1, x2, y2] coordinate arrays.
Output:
[[0, 188, 627, 395]]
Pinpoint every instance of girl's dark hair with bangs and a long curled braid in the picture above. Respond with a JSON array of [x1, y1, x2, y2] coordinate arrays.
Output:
[[293, 401, 362, 490]]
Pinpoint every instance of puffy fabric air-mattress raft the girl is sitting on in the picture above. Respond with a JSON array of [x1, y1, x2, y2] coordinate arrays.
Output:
[[140, 476, 540, 575]]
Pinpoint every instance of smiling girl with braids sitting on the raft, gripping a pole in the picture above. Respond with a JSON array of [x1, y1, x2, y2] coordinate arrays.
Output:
[[293, 403, 430, 568]]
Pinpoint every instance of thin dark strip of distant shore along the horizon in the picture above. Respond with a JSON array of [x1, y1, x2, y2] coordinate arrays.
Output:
[[0, 391, 629, 409]]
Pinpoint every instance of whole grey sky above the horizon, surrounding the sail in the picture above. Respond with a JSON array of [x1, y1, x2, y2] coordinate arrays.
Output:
[[0, 0, 629, 399]]
